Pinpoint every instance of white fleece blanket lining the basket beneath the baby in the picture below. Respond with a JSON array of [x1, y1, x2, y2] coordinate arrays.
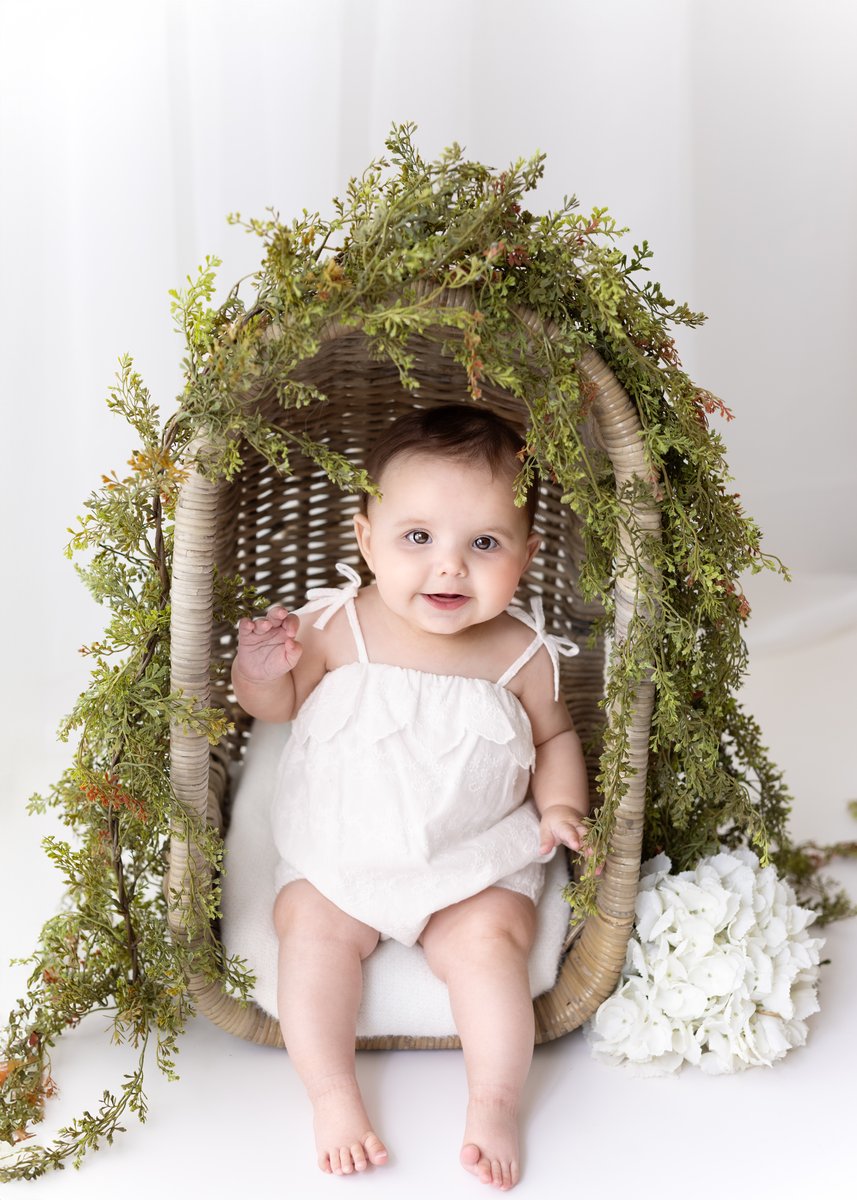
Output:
[[222, 721, 569, 1037]]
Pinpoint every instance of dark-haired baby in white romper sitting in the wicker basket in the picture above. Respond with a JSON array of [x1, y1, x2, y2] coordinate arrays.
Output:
[[233, 404, 589, 1190]]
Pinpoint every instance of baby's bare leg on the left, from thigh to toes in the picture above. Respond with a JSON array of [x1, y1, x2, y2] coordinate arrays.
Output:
[[274, 880, 386, 1175]]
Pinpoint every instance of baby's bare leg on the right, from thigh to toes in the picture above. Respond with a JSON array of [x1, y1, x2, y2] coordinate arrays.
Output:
[[420, 888, 535, 1192]]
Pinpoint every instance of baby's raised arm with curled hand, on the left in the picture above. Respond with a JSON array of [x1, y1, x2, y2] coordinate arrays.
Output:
[[232, 605, 324, 721]]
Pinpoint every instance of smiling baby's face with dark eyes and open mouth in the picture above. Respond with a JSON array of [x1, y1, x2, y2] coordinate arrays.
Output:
[[354, 454, 539, 634]]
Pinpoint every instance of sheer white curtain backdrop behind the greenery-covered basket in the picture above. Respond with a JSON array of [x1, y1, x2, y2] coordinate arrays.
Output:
[[0, 0, 857, 784]]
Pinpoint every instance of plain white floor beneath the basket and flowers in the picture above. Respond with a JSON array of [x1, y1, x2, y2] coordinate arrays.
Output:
[[0, 578, 857, 1200]]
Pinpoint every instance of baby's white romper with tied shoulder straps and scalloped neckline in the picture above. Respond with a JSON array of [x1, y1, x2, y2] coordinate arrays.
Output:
[[271, 563, 577, 946]]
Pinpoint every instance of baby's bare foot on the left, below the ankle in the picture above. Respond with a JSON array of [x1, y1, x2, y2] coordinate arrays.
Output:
[[310, 1075, 386, 1175]]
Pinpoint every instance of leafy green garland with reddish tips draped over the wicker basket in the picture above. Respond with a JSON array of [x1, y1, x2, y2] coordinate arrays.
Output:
[[0, 125, 846, 1180]]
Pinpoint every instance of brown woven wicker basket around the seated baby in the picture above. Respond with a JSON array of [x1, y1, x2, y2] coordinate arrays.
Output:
[[167, 292, 659, 1049]]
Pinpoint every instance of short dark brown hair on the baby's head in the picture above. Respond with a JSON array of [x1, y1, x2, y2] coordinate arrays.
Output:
[[360, 404, 539, 529]]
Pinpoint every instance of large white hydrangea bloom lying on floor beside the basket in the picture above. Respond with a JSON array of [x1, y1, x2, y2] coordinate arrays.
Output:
[[586, 850, 823, 1075]]
